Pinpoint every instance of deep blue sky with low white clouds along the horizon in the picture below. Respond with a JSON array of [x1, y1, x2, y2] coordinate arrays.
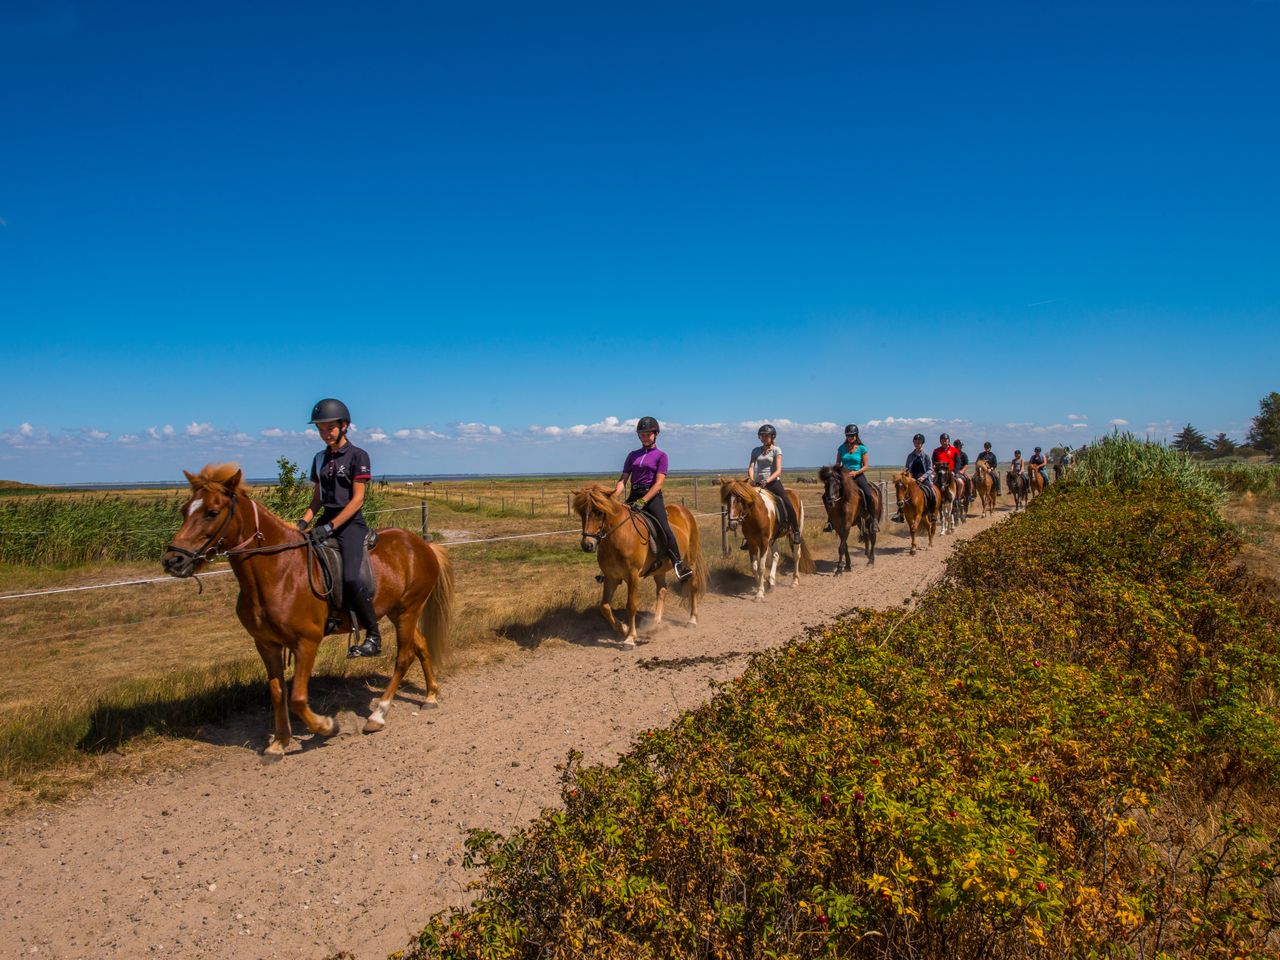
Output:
[[0, 0, 1280, 481]]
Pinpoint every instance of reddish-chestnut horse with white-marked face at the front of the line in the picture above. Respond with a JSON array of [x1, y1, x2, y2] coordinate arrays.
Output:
[[161, 463, 453, 755]]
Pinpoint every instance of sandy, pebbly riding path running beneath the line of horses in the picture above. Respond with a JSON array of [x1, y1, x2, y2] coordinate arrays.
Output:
[[0, 511, 1007, 960]]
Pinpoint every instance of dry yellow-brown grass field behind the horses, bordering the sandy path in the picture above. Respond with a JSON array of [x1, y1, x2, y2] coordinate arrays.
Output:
[[0, 471, 893, 810]]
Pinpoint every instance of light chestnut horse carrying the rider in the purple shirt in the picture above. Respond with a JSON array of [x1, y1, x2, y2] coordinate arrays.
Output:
[[573, 484, 707, 646]]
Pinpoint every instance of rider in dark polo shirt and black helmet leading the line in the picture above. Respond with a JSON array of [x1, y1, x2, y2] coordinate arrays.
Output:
[[298, 397, 383, 657]]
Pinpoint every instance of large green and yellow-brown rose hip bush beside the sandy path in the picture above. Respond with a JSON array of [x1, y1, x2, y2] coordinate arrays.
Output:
[[402, 481, 1280, 959]]
